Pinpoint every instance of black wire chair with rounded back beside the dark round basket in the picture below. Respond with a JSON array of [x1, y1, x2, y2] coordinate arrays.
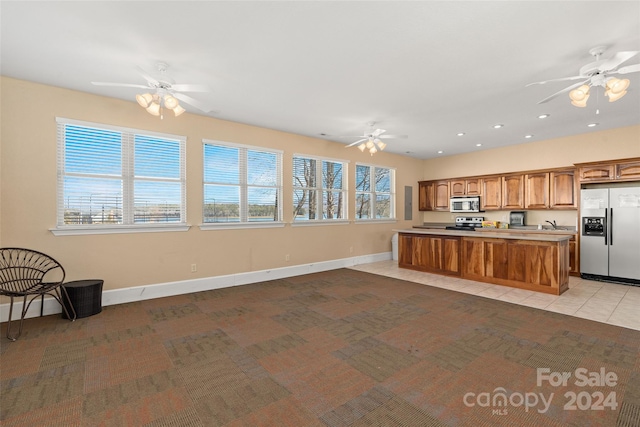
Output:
[[0, 248, 76, 341]]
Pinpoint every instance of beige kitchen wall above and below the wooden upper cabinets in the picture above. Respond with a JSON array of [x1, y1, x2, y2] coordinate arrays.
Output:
[[422, 126, 640, 227]]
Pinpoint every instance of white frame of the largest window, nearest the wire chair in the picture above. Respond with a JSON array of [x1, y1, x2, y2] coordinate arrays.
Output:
[[49, 117, 190, 236]]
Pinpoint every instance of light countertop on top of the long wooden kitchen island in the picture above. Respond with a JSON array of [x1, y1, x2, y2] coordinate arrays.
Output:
[[393, 227, 575, 242]]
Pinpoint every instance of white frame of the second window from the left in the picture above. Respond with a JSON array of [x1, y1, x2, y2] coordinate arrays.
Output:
[[199, 139, 285, 230]]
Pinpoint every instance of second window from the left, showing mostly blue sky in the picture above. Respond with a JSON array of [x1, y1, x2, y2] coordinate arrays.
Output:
[[203, 141, 282, 226]]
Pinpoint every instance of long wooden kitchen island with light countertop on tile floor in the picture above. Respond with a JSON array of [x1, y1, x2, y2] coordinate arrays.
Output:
[[395, 228, 571, 295]]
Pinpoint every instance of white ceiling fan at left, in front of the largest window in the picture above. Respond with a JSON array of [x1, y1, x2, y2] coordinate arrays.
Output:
[[91, 62, 212, 116]]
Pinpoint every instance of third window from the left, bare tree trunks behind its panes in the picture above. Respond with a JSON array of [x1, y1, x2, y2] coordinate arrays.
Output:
[[293, 155, 347, 221]]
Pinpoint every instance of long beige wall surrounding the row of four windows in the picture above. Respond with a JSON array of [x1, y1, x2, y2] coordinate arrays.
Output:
[[0, 77, 423, 290]]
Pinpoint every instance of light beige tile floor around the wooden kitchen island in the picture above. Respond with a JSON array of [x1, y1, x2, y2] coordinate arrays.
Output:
[[352, 260, 640, 331]]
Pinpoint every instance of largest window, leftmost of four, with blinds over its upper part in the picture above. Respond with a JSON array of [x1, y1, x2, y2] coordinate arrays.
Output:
[[54, 118, 186, 233]]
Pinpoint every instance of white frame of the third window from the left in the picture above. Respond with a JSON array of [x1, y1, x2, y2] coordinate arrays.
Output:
[[291, 153, 349, 226]]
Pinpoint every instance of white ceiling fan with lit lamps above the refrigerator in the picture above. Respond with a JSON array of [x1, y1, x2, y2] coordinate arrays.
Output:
[[526, 46, 640, 107]]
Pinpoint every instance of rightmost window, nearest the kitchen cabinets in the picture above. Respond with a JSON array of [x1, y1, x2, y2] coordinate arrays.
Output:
[[356, 164, 395, 220]]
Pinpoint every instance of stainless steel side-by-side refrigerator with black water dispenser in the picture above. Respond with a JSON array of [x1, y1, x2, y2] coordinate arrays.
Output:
[[580, 187, 640, 285]]
